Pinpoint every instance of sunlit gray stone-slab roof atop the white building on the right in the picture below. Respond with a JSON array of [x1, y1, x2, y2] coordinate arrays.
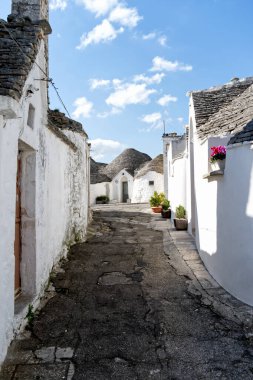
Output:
[[192, 77, 253, 142]]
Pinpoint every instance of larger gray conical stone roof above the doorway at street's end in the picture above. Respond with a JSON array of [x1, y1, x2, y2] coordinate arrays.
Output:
[[104, 148, 151, 179]]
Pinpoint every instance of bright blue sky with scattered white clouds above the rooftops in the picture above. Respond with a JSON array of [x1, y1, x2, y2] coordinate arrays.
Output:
[[0, 0, 253, 162]]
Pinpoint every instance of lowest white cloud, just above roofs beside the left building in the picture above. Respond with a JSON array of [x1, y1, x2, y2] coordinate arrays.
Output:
[[90, 139, 126, 161]]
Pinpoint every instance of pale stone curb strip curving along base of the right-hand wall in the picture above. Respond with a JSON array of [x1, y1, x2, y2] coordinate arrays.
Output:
[[151, 218, 253, 338]]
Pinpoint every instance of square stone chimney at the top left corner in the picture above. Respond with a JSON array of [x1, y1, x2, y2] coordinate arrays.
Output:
[[11, 0, 48, 21]]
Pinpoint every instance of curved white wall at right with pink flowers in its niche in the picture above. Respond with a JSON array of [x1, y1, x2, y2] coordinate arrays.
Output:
[[187, 96, 253, 305]]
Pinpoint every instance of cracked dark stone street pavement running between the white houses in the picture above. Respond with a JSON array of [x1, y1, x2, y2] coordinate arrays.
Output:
[[0, 205, 253, 380]]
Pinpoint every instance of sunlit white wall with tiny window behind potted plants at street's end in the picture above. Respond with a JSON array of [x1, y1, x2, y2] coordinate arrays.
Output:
[[131, 171, 164, 203]]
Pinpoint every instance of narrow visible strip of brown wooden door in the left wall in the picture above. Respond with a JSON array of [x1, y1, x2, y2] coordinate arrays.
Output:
[[14, 158, 21, 296]]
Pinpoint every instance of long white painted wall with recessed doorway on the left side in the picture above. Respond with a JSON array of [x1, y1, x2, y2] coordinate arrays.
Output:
[[0, 35, 89, 363]]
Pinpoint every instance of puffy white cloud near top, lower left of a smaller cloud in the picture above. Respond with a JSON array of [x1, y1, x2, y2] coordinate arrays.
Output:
[[77, 19, 124, 49]]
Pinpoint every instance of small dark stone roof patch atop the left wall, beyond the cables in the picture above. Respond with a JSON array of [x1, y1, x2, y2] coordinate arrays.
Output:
[[48, 110, 88, 137]]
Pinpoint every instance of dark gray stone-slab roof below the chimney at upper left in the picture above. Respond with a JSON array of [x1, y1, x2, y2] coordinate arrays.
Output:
[[0, 15, 43, 101]]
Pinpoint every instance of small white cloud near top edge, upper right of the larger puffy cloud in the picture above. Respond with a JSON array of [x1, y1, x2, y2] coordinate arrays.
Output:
[[109, 4, 142, 28]]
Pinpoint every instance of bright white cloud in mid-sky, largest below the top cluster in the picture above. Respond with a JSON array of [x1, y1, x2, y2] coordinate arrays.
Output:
[[106, 83, 156, 108]]
